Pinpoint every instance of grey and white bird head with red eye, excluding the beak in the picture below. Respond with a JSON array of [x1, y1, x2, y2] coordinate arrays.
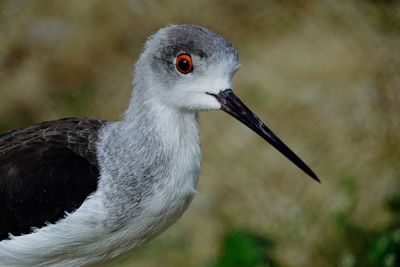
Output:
[[136, 25, 239, 111]]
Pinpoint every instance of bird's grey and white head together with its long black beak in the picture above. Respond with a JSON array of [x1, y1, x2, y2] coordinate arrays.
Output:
[[134, 25, 319, 181]]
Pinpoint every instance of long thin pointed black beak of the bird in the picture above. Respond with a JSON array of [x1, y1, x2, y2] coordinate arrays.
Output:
[[207, 89, 321, 182]]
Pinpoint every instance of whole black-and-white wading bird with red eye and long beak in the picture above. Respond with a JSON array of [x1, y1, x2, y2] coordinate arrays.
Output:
[[0, 24, 320, 267]]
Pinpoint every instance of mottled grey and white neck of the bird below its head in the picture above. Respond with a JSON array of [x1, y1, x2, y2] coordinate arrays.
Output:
[[99, 82, 201, 223]]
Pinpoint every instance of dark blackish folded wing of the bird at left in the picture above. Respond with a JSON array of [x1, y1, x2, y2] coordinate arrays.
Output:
[[0, 118, 105, 241]]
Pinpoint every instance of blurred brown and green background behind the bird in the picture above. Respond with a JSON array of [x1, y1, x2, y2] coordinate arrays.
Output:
[[0, 0, 400, 267]]
